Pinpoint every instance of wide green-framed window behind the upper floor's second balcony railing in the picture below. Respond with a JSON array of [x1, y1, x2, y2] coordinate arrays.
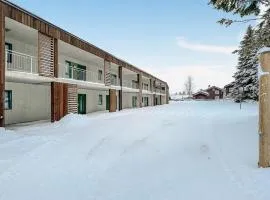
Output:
[[66, 61, 86, 81]]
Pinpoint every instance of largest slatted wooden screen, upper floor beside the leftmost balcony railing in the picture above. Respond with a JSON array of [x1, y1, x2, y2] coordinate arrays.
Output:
[[38, 33, 56, 77]]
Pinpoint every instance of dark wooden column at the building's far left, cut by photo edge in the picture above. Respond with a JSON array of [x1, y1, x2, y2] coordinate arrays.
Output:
[[0, 2, 6, 127]]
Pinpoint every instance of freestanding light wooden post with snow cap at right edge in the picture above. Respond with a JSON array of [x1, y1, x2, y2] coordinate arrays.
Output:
[[258, 51, 270, 168]]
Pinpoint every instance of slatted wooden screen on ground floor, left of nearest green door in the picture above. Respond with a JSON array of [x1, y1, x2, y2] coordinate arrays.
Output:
[[68, 84, 78, 113]]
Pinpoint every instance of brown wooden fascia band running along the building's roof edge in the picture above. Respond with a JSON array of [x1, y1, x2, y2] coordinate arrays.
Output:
[[1, 0, 166, 84]]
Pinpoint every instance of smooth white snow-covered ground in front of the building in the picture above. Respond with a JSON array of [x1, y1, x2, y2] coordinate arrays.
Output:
[[0, 101, 270, 200]]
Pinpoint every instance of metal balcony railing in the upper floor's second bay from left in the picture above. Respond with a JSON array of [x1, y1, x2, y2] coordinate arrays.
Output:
[[59, 64, 101, 83]]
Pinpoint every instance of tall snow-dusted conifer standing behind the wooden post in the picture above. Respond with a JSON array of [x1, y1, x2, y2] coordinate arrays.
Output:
[[233, 26, 259, 100]]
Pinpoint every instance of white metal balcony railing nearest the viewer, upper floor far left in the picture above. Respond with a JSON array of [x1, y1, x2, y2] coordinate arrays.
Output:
[[5, 50, 38, 74]]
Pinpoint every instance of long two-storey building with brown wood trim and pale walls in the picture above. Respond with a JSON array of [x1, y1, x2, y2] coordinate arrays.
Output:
[[0, 0, 169, 126]]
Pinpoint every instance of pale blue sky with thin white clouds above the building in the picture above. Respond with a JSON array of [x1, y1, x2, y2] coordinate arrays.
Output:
[[12, 0, 251, 92]]
